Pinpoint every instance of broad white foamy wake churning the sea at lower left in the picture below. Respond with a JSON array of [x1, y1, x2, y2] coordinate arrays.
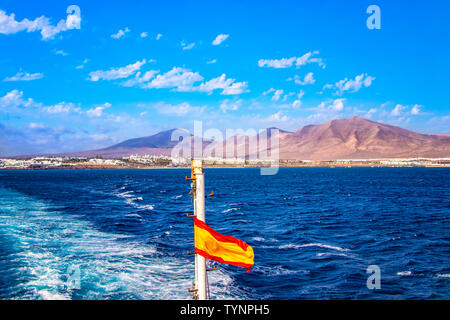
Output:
[[0, 189, 241, 299]]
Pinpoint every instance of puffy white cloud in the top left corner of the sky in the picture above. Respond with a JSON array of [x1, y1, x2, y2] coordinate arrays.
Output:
[[0, 10, 81, 40]]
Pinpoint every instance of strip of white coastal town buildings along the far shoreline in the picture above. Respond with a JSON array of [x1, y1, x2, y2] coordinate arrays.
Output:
[[0, 155, 450, 170]]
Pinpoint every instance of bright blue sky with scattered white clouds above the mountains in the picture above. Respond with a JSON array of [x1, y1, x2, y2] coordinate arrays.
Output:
[[0, 0, 450, 156]]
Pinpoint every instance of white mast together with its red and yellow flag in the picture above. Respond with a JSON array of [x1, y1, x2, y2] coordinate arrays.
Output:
[[186, 159, 254, 300]]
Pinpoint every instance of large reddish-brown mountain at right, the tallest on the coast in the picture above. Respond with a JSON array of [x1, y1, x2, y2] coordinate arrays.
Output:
[[280, 117, 450, 160]]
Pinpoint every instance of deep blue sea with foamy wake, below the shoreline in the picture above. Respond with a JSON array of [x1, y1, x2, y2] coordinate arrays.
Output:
[[0, 168, 450, 299]]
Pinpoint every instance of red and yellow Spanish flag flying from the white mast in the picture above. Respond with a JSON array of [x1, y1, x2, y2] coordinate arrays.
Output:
[[194, 218, 254, 273]]
